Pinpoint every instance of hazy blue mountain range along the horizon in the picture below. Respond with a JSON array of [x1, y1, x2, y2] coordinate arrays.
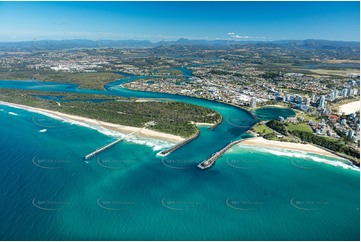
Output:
[[0, 38, 360, 51]]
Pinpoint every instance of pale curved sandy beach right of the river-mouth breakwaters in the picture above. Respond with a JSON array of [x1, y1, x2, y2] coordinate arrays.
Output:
[[239, 137, 340, 158]]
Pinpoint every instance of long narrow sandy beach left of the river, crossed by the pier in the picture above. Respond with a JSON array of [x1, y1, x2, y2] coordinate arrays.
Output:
[[0, 101, 185, 143]]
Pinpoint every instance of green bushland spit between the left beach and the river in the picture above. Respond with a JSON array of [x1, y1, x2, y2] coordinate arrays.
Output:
[[0, 89, 221, 137]]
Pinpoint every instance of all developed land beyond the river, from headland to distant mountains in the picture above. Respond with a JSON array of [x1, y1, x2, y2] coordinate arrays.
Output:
[[0, 41, 360, 164]]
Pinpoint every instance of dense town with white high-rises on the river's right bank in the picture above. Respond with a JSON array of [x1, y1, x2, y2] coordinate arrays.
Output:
[[124, 61, 360, 164]]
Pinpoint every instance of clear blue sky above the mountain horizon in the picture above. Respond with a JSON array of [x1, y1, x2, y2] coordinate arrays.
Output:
[[0, 1, 360, 42]]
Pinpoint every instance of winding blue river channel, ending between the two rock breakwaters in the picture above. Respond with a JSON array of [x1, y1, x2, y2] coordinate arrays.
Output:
[[0, 67, 292, 162]]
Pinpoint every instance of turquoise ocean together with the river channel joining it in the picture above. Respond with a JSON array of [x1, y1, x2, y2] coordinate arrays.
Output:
[[0, 70, 360, 240]]
